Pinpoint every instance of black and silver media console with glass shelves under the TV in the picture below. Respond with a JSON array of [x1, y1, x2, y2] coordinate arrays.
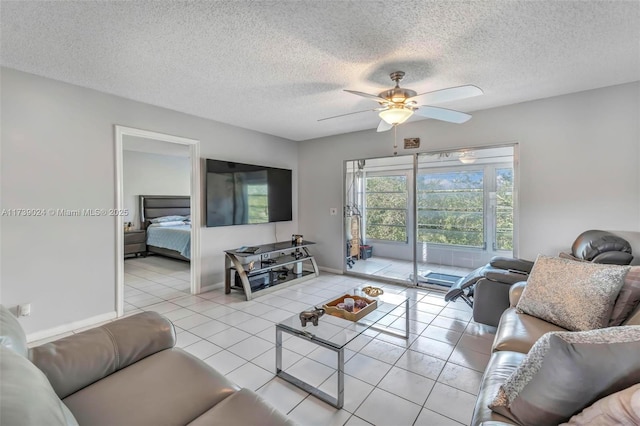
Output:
[[224, 241, 319, 300]]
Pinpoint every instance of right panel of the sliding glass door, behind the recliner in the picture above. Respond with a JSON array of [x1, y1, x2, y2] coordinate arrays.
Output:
[[416, 146, 514, 285]]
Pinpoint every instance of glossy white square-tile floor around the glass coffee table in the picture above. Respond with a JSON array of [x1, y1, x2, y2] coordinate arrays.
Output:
[[52, 257, 495, 426]]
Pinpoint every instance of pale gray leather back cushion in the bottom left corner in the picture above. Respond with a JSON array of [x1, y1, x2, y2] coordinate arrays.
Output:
[[0, 346, 78, 426]]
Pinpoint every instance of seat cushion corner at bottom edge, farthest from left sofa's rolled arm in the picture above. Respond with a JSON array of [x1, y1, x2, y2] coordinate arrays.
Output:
[[189, 389, 295, 426]]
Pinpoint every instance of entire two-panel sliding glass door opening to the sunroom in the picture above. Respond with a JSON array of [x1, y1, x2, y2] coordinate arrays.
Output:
[[345, 146, 517, 287]]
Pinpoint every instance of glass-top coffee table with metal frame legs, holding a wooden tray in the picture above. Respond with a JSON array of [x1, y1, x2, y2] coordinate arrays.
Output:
[[276, 289, 409, 408]]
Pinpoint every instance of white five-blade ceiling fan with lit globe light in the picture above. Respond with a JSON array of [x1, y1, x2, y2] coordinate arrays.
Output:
[[318, 71, 483, 132]]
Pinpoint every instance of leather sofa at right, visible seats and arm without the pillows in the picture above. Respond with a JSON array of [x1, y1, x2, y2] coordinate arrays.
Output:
[[471, 282, 640, 426]]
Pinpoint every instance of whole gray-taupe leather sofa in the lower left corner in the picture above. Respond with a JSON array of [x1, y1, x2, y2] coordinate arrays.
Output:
[[0, 306, 293, 426]]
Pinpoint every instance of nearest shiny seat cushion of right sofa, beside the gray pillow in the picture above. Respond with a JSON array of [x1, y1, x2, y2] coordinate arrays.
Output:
[[471, 351, 526, 426]]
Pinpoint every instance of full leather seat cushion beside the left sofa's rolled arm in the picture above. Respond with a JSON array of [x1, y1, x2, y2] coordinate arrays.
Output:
[[63, 348, 239, 426]]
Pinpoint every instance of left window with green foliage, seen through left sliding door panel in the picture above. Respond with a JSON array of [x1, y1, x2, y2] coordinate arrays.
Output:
[[365, 175, 408, 243]]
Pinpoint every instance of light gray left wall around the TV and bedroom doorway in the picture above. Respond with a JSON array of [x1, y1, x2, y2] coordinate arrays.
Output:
[[0, 68, 298, 333]]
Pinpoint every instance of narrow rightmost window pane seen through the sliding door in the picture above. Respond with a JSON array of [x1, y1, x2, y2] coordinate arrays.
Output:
[[495, 168, 513, 250]]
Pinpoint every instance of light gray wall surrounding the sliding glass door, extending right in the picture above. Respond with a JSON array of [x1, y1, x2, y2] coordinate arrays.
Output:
[[299, 82, 640, 270]]
